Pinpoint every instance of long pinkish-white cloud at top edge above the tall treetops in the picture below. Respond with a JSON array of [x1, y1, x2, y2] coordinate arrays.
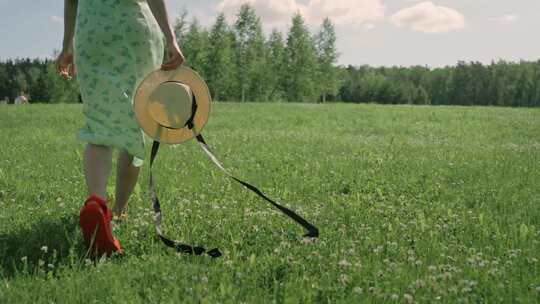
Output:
[[217, 0, 385, 25]]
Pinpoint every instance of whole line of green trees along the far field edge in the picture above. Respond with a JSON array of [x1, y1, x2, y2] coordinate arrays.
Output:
[[0, 4, 540, 107]]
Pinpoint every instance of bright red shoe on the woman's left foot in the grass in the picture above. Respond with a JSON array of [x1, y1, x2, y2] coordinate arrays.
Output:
[[79, 195, 124, 256]]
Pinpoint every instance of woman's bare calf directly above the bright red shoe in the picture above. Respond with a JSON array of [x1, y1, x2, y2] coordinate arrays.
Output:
[[84, 144, 112, 199]]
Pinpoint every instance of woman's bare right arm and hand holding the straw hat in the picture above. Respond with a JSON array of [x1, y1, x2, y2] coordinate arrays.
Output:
[[147, 0, 185, 70]]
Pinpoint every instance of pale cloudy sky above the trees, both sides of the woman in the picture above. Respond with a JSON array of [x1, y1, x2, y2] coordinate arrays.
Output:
[[0, 0, 540, 67]]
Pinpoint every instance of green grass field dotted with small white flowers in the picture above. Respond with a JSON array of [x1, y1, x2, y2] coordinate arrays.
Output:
[[0, 103, 540, 303]]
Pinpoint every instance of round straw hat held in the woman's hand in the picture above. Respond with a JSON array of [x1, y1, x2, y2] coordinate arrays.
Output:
[[134, 67, 212, 144]]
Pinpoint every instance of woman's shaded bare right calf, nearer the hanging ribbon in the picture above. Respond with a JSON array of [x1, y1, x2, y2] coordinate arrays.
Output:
[[113, 151, 140, 216]]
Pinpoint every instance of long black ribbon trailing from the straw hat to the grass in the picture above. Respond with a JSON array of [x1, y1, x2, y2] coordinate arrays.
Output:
[[150, 95, 319, 258]]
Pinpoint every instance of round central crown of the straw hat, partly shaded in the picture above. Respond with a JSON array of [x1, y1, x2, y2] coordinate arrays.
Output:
[[147, 81, 193, 129]]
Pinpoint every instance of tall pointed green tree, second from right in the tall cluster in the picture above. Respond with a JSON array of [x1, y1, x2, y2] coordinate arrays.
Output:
[[285, 13, 317, 102]]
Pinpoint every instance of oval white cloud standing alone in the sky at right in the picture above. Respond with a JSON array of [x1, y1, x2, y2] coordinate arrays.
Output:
[[390, 1, 465, 33]]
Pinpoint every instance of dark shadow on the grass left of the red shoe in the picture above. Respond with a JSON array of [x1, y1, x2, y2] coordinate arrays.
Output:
[[0, 216, 85, 278]]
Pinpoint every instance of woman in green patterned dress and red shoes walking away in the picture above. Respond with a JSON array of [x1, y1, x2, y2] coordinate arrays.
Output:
[[57, 0, 184, 255]]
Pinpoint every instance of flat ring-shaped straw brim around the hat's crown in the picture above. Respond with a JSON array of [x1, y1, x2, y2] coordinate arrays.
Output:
[[133, 67, 212, 144]]
